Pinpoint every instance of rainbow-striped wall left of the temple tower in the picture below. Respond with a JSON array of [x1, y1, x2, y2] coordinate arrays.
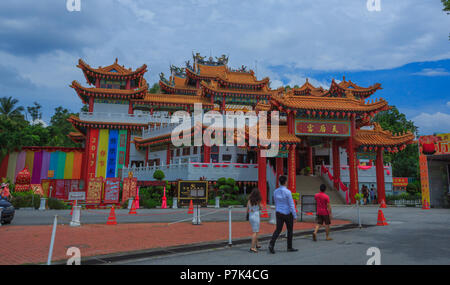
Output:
[[0, 147, 83, 184]]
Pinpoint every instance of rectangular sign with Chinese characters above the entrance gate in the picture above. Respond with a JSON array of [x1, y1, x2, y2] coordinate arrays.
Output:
[[295, 119, 350, 137]]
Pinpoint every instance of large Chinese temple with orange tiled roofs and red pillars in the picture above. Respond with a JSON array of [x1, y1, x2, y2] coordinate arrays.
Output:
[[0, 53, 414, 203]]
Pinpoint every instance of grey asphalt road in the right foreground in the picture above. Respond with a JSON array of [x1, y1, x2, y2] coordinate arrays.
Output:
[[115, 207, 450, 265]]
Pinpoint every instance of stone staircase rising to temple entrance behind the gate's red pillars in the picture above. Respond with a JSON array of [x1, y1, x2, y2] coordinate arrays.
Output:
[[296, 175, 345, 205]]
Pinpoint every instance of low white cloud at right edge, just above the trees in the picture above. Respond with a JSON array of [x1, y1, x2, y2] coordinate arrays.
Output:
[[412, 111, 450, 135]]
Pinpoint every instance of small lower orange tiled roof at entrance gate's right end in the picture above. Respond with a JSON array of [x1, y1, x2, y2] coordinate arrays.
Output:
[[355, 123, 414, 147]]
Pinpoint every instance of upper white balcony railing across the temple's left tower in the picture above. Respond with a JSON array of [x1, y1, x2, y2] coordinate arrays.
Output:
[[80, 112, 170, 124]]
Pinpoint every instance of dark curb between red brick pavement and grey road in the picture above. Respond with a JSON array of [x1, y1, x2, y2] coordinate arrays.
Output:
[[52, 224, 373, 265]]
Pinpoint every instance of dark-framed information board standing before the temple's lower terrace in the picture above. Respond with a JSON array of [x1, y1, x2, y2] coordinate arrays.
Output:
[[178, 181, 208, 206]]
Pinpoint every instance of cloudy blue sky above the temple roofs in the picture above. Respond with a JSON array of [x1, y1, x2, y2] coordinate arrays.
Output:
[[0, 0, 450, 134]]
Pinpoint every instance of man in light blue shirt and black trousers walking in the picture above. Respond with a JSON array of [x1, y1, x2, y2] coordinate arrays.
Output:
[[269, 175, 298, 253]]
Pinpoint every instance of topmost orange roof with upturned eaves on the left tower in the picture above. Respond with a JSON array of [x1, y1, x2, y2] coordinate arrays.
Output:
[[77, 58, 147, 84]]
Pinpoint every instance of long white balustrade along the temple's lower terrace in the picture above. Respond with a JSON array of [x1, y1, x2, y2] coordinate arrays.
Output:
[[122, 162, 258, 181]]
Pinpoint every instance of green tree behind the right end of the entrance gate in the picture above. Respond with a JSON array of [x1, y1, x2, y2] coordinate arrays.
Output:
[[373, 106, 419, 178]]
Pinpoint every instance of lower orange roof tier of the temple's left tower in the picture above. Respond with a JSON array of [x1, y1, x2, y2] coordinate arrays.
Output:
[[70, 81, 147, 104]]
